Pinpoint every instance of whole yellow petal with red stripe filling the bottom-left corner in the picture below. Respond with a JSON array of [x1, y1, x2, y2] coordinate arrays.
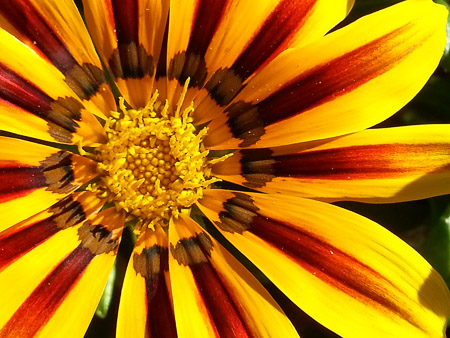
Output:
[[0, 209, 125, 337]]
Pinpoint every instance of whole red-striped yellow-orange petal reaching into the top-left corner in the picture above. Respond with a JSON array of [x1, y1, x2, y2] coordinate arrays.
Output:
[[0, 0, 115, 116]]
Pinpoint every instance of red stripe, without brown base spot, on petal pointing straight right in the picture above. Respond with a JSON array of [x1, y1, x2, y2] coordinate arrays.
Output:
[[253, 144, 445, 180]]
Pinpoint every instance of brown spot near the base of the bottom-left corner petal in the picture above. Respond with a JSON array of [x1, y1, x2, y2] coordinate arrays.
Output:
[[78, 220, 119, 255]]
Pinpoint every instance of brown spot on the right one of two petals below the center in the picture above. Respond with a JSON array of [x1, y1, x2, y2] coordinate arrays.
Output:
[[170, 232, 212, 266]]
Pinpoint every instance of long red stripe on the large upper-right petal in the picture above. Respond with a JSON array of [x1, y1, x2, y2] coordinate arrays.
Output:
[[257, 26, 413, 125]]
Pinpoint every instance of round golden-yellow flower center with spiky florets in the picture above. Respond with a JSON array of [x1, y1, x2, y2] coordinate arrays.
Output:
[[90, 86, 219, 225]]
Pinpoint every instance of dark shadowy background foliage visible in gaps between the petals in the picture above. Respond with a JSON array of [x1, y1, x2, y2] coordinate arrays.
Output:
[[81, 0, 450, 337]]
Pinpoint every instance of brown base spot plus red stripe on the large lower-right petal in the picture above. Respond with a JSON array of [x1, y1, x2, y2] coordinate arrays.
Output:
[[216, 193, 419, 327]]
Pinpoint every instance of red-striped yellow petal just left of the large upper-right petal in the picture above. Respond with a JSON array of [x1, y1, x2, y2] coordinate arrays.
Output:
[[192, 0, 353, 123]]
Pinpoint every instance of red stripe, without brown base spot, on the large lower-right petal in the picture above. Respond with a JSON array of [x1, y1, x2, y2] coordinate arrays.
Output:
[[248, 215, 414, 323]]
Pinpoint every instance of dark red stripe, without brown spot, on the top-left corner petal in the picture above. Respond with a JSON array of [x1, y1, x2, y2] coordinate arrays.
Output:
[[0, 0, 76, 72]]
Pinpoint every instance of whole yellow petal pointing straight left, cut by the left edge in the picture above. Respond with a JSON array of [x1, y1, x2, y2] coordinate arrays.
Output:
[[0, 137, 97, 231]]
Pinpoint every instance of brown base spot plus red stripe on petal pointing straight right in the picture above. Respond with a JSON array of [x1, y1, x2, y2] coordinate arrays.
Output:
[[240, 144, 447, 184]]
